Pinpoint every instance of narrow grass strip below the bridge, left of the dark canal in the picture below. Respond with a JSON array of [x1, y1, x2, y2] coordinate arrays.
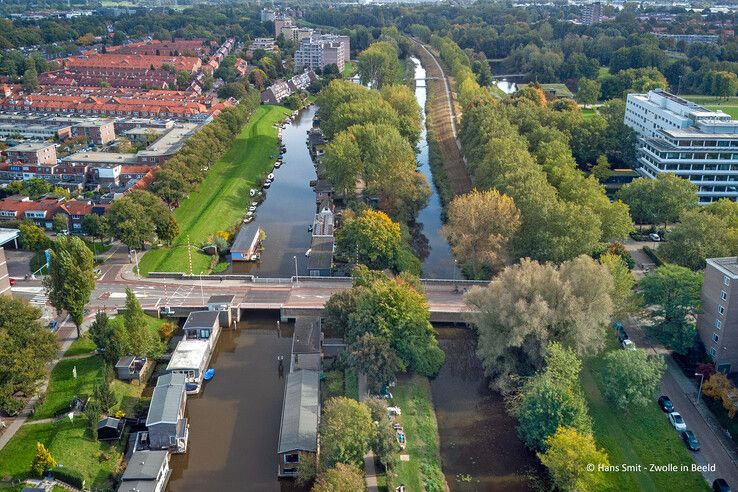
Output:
[[387, 375, 445, 490]]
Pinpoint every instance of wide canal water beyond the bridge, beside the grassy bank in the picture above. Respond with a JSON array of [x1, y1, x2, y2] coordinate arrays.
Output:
[[229, 105, 316, 277]]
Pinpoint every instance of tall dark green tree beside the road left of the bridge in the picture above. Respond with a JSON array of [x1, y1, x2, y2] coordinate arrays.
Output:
[[44, 236, 95, 338]]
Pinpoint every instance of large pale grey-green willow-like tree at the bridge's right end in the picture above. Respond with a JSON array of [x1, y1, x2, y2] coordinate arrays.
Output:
[[465, 256, 613, 391]]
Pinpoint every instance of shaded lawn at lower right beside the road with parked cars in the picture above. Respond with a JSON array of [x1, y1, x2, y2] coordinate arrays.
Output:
[[581, 340, 707, 491]]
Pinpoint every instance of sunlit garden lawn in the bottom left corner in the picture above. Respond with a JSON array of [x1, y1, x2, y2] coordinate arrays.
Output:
[[0, 417, 122, 490]]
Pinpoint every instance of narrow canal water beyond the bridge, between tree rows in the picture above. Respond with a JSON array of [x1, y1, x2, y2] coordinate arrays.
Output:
[[410, 57, 460, 278]]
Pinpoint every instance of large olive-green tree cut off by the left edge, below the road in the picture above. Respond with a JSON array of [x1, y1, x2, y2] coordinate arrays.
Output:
[[0, 296, 58, 415]]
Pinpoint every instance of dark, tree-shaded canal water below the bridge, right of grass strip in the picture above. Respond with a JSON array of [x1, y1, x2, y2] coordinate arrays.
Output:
[[431, 327, 541, 492]]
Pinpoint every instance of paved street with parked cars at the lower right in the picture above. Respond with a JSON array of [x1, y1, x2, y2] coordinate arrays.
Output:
[[626, 320, 738, 489]]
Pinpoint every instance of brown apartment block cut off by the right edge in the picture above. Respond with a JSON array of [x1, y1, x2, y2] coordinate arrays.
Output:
[[697, 256, 738, 374]]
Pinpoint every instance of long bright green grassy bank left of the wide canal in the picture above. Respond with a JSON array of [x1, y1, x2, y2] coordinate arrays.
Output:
[[140, 106, 289, 274]]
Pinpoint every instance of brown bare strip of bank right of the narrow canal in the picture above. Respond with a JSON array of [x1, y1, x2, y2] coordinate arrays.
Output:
[[415, 41, 472, 195]]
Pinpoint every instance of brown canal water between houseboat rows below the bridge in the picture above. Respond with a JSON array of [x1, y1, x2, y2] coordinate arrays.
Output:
[[167, 313, 299, 492]]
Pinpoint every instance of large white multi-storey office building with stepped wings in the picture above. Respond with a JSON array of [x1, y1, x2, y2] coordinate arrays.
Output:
[[625, 89, 738, 203]]
